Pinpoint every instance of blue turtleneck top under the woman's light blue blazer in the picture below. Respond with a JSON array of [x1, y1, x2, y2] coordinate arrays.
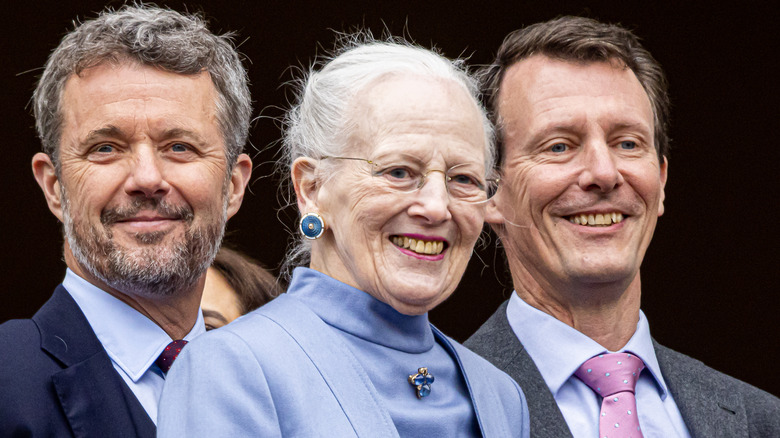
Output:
[[287, 268, 480, 437]]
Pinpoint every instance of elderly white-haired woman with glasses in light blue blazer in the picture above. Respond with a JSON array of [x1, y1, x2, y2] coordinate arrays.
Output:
[[159, 37, 529, 437]]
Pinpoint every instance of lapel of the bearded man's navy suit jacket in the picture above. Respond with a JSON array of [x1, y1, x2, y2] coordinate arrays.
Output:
[[33, 286, 155, 437]]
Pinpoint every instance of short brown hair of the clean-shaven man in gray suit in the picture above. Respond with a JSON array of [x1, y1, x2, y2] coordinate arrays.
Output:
[[480, 16, 670, 162]]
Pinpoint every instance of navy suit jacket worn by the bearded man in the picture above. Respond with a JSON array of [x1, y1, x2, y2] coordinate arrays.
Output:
[[0, 285, 155, 438]]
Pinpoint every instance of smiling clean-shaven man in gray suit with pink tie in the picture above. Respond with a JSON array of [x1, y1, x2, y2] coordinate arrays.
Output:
[[466, 17, 780, 437]]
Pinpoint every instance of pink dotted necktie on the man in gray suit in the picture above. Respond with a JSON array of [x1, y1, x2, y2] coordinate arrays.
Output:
[[574, 353, 645, 438]]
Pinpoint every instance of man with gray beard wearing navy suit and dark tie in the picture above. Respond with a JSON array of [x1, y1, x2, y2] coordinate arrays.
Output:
[[0, 5, 252, 437]]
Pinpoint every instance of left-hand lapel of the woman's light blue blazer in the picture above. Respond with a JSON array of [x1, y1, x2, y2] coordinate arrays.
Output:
[[264, 297, 398, 438]]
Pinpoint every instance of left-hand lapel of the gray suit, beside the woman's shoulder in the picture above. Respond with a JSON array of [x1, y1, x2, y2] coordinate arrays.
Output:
[[465, 302, 572, 438]]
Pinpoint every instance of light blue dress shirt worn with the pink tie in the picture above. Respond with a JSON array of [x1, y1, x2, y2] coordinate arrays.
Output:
[[506, 292, 690, 438]]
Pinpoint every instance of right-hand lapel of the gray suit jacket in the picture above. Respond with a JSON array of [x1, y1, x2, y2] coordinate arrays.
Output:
[[653, 340, 748, 437]]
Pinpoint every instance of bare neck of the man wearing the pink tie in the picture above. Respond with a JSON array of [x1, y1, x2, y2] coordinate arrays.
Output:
[[512, 262, 641, 351]]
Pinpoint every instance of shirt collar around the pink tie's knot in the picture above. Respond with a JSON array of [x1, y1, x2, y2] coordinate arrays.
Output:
[[506, 292, 667, 400]]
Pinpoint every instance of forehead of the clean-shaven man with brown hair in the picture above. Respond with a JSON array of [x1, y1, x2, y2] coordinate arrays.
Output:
[[497, 55, 654, 154]]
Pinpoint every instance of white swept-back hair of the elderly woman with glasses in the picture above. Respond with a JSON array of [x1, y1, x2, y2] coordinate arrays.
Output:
[[280, 31, 496, 272]]
